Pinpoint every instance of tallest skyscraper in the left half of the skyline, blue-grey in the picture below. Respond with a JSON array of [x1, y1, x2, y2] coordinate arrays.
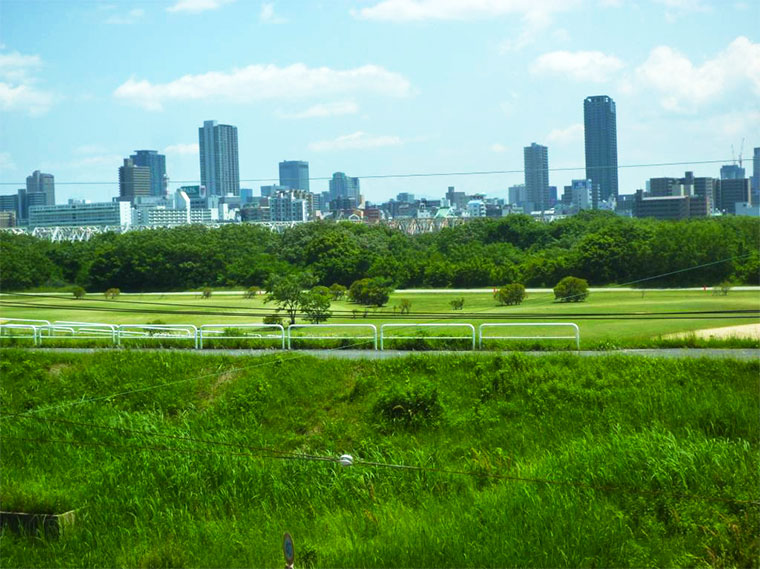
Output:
[[198, 121, 240, 196]]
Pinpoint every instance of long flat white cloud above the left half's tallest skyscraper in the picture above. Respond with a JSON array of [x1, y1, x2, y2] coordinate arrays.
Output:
[[114, 63, 411, 111]]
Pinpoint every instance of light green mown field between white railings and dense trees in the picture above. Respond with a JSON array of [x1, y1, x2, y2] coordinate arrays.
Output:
[[0, 290, 760, 348]]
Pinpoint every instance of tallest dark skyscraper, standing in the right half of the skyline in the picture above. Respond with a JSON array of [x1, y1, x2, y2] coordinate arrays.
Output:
[[583, 95, 618, 200]]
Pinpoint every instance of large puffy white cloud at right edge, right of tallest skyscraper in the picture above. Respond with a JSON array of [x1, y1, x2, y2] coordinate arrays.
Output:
[[624, 36, 760, 113]]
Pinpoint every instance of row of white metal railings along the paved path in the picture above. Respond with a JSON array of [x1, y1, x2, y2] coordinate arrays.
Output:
[[0, 318, 581, 350]]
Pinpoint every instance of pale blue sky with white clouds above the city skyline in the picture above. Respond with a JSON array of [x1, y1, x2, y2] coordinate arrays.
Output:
[[0, 0, 760, 202]]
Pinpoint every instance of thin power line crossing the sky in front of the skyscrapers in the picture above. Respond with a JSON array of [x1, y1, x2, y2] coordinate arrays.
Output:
[[0, 159, 731, 186]]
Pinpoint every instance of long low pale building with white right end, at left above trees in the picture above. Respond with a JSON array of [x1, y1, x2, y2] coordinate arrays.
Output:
[[29, 201, 132, 227]]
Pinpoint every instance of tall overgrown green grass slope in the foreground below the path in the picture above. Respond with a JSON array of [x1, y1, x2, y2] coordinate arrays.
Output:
[[0, 350, 760, 567]]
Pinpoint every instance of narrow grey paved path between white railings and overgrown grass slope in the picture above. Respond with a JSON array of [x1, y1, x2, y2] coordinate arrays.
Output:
[[0, 348, 760, 361]]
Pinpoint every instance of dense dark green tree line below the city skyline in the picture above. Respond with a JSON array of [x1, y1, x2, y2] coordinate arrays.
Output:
[[0, 212, 760, 292]]
